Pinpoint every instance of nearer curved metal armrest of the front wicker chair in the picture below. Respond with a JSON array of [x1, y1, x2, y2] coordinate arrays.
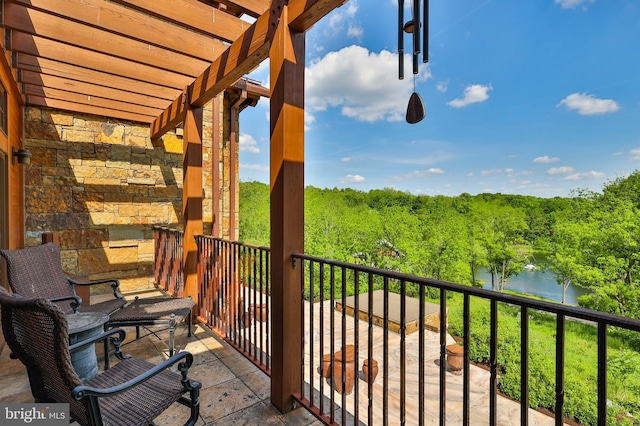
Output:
[[71, 352, 201, 401]]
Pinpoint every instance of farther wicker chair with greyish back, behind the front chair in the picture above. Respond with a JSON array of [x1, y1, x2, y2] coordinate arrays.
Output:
[[0, 243, 126, 315]]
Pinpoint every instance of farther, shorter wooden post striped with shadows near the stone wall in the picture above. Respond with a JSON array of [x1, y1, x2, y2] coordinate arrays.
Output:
[[179, 101, 203, 304]]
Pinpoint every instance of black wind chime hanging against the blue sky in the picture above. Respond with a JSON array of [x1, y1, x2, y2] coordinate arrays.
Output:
[[398, 0, 429, 124]]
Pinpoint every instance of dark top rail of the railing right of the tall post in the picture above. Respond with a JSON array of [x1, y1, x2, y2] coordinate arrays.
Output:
[[292, 253, 640, 331]]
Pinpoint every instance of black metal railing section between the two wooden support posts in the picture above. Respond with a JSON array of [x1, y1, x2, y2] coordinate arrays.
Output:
[[195, 235, 271, 374]]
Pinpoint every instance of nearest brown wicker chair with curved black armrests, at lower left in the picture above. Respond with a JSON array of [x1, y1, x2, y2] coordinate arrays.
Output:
[[0, 291, 201, 426]]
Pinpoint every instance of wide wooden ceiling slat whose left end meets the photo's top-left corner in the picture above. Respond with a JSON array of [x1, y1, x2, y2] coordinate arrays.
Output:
[[4, 3, 208, 77]]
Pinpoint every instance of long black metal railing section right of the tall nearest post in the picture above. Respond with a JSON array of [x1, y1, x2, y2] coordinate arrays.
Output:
[[293, 254, 640, 425]]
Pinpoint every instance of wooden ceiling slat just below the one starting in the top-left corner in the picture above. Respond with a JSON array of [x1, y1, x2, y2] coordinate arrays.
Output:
[[11, 31, 193, 88]]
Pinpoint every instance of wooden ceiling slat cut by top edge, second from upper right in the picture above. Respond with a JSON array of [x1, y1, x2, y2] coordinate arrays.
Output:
[[113, 0, 250, 42]]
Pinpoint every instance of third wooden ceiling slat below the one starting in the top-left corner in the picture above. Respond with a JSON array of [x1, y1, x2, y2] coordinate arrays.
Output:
[[20, 71, 172, 109]]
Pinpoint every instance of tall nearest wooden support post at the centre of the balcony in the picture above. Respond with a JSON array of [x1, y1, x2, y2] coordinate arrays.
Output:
[[269, 2, 305, 412]]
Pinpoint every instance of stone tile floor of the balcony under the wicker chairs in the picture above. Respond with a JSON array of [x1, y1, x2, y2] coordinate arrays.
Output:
[[0, 304, 322, 426]]
